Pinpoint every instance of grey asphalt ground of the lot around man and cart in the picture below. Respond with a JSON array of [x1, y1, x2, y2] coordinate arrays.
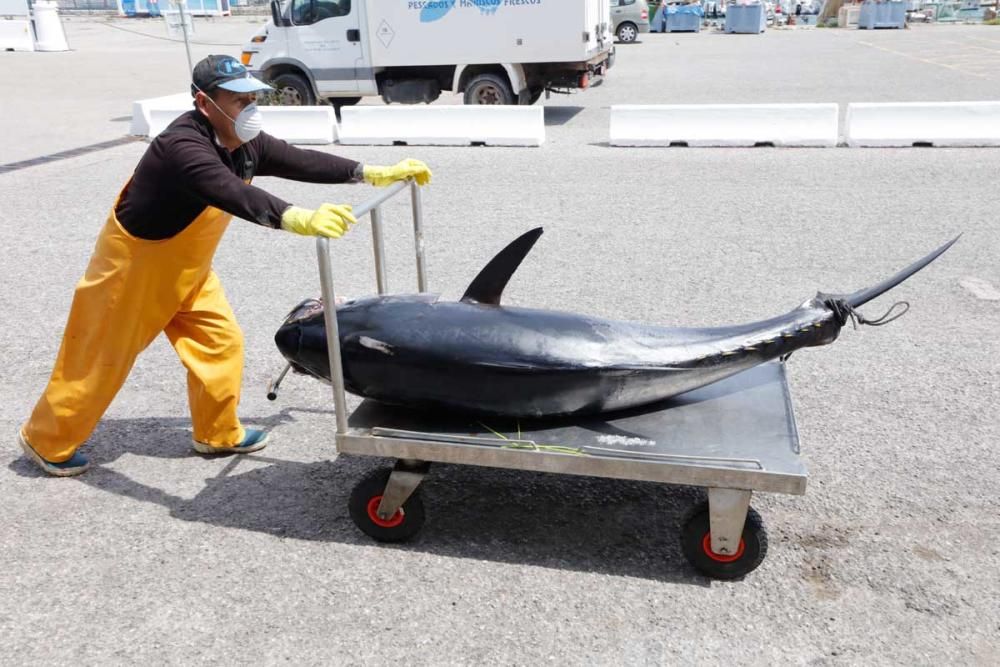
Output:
[[0, 17, 1000, 665]]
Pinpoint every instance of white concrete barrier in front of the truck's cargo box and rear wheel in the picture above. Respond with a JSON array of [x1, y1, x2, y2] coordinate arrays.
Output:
[[340, 105, 545, 146]]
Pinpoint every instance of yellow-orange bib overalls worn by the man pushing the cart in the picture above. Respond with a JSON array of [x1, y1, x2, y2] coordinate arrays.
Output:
[[22, 185, 244, 463]]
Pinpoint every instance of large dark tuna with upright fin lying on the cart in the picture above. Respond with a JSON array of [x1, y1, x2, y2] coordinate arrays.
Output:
[[275, 230, 954, 417]]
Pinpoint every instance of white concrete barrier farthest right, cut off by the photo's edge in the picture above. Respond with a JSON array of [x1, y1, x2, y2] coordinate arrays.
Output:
[[845, 102, 1000, 147]]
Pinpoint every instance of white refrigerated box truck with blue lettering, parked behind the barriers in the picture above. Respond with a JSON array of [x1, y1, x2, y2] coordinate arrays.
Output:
[[241, 0, 614, 107]]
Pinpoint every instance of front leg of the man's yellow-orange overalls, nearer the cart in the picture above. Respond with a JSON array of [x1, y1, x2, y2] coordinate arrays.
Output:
[[164, 271, 245, 447]]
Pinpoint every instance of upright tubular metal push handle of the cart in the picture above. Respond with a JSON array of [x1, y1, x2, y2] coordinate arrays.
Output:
[[316, 178, 427, 435]]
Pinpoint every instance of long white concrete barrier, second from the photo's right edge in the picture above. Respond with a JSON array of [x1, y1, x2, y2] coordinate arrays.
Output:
[[611, 103, 839, 147]]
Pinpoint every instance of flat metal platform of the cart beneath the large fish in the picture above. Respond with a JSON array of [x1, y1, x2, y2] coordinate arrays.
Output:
[[338, 362, 807, 494]]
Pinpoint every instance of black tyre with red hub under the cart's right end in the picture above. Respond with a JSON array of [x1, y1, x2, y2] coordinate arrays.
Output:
[[681, 503, 767, 579]]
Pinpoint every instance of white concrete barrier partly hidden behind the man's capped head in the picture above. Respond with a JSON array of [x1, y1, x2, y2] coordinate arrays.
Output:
[[137, 93, 337, 144]]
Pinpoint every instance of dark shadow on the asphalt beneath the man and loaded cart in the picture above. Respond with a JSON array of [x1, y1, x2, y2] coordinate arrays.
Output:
[[10, 410, 708, 586]]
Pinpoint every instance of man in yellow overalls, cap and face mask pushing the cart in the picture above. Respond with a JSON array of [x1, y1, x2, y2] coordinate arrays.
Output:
[[18, 56, 431, 477]]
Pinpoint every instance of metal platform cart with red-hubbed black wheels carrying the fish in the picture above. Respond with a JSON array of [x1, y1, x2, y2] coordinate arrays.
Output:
[[268, 182, 807, 579]]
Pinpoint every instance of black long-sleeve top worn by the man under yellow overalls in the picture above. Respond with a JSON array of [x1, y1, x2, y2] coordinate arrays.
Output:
[[115, 110, 358, 241]]
